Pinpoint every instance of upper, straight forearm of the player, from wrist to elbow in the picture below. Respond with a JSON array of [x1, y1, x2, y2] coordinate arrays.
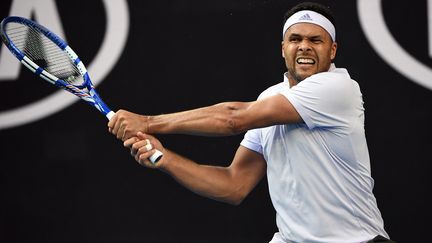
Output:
[[147, 102, 249, 136]]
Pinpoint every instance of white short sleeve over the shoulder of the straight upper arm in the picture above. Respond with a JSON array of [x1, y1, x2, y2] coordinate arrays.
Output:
[[281, 72, 358, 129]]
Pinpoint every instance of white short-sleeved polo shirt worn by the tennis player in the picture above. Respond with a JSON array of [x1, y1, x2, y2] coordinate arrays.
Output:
[[241, 65, 388, 243]]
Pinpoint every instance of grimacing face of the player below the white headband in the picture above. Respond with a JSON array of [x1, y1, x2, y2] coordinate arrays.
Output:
[[282, 23, 337, 85]]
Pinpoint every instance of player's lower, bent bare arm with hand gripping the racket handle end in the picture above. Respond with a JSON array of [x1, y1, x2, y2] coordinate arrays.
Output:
[[124, 133, 267, 205]]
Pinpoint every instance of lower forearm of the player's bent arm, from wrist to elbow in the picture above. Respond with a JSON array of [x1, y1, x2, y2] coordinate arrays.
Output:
[[160, 150, 248, 205]]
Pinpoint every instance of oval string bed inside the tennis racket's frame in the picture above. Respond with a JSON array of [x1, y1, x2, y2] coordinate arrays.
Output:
[[6, 23, 84, 85]]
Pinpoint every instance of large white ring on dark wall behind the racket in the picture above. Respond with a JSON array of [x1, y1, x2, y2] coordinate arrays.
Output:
[[0, 0, 129, 129]]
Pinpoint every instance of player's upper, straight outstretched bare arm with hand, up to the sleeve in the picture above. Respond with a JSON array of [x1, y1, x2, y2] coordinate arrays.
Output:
[[108, 95, 302, 141]]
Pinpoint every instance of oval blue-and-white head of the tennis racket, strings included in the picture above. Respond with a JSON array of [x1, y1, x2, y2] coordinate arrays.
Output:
[[0, 16, 84, 86]]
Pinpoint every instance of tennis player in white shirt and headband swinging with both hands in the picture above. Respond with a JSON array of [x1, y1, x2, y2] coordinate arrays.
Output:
[[108, 3, 392, 243]]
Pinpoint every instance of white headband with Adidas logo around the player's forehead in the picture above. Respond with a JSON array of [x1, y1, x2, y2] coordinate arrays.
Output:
[[282, 10, 336, 41]]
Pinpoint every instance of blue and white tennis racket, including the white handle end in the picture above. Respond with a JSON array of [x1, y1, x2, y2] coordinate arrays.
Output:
[[0, 16, 163, 163]]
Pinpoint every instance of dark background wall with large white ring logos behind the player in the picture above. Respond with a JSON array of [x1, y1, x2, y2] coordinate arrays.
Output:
[[0, 0, 432, 243]]
